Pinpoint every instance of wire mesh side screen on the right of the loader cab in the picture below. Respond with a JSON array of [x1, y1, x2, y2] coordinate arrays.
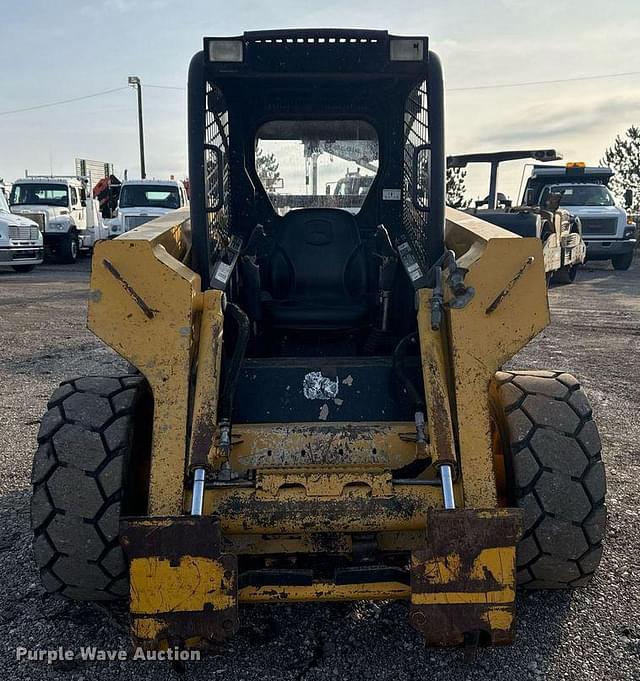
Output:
[[402, 81, 430, 266]]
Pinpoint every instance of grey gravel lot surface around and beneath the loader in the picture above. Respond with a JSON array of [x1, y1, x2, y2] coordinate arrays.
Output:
[[0, 260, 640, 681]]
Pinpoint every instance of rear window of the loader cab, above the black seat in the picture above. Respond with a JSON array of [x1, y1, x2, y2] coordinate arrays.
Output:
[[255, 121, 379, 215]]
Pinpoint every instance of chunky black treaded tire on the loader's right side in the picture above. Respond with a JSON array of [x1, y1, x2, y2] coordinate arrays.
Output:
[[496, 371, 606, 589]]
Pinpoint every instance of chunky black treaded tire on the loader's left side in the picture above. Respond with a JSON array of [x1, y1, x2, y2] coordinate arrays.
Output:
[[31, 376, 151, 601]]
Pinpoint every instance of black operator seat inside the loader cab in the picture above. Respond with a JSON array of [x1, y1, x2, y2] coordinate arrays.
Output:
[[263, 208, 368, 330]]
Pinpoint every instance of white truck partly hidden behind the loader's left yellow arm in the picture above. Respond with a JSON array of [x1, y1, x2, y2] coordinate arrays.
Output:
[[105, 180, 189, 239]]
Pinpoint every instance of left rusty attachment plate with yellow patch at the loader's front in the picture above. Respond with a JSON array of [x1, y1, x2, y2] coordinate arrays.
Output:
[[120, 516, 238, 646]]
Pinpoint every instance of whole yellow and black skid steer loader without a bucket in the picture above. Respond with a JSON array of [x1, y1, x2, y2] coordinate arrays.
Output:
[[32, 30, 605, 646]]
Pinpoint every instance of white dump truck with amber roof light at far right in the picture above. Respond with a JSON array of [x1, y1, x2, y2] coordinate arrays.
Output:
[[522, 163, 636, 270]]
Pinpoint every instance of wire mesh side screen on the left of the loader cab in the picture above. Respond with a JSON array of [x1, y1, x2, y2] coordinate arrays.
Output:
[[204, 83, 230, 257]]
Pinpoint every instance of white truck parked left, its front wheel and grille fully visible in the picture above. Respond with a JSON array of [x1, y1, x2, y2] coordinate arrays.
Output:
[[9, 176, 104, 263]]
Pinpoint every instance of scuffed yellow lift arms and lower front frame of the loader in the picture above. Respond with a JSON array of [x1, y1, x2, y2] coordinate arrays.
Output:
[[89, 209, 549, 644]]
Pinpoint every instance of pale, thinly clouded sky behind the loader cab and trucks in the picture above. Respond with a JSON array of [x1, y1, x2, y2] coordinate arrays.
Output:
[[0, 0, 640, 198]]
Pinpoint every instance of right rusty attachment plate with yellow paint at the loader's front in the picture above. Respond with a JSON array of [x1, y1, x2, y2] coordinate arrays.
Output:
[[409, 508, 522, 646]]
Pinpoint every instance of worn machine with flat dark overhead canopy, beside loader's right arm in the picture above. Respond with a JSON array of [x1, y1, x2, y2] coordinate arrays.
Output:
[[447, 149, 586, 284]]
